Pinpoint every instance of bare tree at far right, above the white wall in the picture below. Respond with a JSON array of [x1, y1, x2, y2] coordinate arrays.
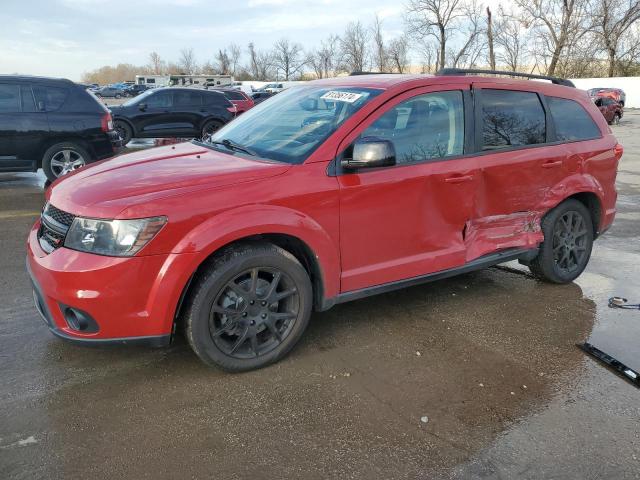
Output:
[[593, 0, 640, 77]]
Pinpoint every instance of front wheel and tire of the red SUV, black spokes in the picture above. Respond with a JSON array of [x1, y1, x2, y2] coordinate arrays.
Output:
[[183, 243, 313, 372]]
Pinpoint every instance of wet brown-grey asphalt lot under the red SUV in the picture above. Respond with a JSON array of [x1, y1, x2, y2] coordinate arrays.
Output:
[[0, 111, 640, 479]]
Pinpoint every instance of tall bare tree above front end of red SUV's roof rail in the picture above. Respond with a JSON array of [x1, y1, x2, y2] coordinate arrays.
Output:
[[407, 0, 464, 69]]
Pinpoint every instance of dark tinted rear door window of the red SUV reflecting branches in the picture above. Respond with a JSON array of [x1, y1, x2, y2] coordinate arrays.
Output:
[[481, 90, 546, 150]]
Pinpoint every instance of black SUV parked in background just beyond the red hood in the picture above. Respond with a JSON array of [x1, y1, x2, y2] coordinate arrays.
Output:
[[109, 87, 236, 144]]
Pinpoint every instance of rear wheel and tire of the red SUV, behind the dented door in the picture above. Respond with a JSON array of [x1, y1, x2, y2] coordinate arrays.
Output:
[[529, 199, 593, 283]]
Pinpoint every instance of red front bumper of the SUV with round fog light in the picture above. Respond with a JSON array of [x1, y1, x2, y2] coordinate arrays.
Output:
[[27, 222, 192, 346]]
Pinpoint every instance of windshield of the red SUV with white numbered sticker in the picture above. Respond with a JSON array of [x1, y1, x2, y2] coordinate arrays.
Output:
[[210, 85, 382, 163]]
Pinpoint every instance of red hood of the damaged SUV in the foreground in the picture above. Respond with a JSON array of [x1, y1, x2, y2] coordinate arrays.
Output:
[[47, 142, 291, 218]]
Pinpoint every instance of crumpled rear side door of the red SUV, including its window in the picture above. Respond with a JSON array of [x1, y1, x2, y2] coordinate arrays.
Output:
[[465, 82, 567, 261]]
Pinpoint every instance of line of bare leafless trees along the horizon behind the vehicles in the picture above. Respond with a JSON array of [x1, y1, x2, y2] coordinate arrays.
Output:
[[83, 0, 640, 84]]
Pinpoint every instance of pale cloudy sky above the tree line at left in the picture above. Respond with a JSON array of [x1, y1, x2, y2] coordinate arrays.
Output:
[[0, 0, 412, 81]]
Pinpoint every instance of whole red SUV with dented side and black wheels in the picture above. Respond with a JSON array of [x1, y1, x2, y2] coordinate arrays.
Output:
[[27, 74, 622, 371]]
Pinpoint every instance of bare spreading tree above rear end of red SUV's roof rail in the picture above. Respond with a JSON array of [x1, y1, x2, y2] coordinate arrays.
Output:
[[514, 0, 588, 75]]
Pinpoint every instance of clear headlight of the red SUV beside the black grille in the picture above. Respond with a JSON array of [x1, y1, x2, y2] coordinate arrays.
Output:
[[64, 217, 167, 257]]
